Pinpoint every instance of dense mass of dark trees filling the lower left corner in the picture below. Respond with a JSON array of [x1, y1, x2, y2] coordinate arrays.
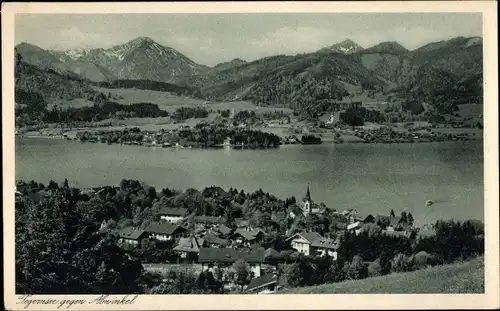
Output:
[[15, 190, 143, 294]]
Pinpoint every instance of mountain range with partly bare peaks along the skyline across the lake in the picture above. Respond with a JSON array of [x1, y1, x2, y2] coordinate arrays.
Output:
[[15, 37, 483, 115]]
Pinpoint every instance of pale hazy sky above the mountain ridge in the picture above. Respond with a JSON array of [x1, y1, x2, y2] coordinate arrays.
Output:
[[15, 13, 482, 66]]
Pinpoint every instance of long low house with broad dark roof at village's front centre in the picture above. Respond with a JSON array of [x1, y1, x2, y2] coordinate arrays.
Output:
[[198, 248, 264, 277]]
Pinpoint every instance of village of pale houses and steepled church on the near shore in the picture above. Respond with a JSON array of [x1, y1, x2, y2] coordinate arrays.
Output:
[[112, 187, 434, 294]]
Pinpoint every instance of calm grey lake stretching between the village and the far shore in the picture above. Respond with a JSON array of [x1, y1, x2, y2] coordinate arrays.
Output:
[[15, 138, 484, 224]]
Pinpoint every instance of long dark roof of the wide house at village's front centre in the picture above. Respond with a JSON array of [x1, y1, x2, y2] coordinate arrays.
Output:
[[198, 247, 264, 263]]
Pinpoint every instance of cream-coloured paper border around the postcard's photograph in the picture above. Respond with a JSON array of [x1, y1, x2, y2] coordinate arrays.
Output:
[[2, 1, 500, 310]]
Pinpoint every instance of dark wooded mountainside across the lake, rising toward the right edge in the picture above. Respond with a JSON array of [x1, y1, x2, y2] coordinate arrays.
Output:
[[184, 38, 482, 114]]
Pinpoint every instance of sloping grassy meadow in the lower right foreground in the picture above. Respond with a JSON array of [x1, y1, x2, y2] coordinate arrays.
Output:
[[280, 257, 484, 294]]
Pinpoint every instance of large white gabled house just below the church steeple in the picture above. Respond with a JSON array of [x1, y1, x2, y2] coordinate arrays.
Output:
[[289, 232, 338, 260]]
